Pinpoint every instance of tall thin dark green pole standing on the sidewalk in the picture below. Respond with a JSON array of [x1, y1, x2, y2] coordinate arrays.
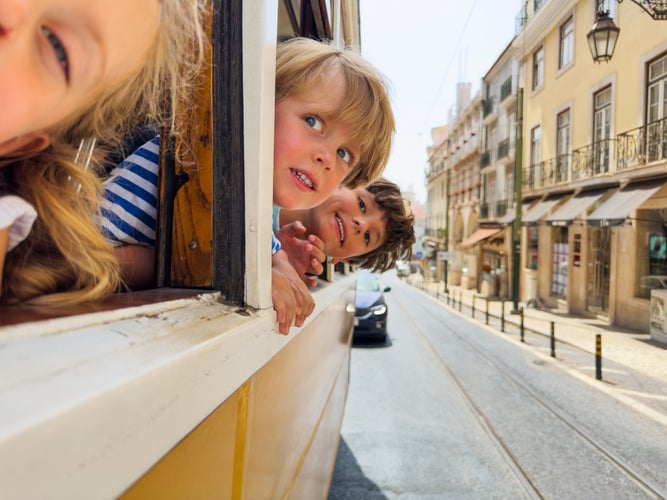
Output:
[[512, 88, 523, 314]]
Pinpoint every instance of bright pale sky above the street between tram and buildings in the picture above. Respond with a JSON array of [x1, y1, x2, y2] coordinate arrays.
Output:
[[359, 0, 521, 202]]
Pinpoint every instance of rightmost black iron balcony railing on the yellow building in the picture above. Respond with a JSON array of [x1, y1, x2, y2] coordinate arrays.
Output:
[[616, 118, 667, 170]]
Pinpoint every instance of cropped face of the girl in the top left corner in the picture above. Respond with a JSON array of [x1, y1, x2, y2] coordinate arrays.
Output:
[[0, 0, 160, 147]]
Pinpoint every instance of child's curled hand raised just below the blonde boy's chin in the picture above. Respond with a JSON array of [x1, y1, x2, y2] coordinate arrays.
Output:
[[276, 221, 326, 288]]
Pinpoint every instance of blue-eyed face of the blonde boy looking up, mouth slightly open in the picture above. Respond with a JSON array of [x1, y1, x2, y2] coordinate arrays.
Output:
[[273, 70, 360, 210]]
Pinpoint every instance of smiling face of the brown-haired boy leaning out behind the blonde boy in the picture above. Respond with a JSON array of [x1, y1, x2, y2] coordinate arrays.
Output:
[[306, 187, 387, 259]]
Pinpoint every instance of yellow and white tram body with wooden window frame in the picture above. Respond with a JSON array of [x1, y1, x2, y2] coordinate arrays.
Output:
[[0, 0, 359, 499]]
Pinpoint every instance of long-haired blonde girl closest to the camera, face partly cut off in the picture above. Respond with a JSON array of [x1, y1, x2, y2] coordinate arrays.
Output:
[[0, 0, 205, 304]]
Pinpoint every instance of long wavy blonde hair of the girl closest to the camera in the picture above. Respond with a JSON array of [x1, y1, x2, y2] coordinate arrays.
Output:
[[0, 0, 207, 304]]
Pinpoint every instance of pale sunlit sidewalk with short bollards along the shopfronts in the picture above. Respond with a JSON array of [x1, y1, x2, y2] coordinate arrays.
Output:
[[405, 273, 667, 380]]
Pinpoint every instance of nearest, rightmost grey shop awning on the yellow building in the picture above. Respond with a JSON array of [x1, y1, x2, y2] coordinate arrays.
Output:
[[586, 182, 664, 227]]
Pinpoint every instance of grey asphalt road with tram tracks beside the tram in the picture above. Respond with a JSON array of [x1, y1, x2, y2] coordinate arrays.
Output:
[[329, 273, 667, 500]]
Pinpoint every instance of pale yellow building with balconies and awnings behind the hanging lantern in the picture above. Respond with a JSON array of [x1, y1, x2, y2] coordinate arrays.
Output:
[[513, 0, 667, 331]]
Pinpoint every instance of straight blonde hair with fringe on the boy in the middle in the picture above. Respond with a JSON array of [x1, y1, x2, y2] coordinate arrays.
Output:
[[276, 38, 394, 189]]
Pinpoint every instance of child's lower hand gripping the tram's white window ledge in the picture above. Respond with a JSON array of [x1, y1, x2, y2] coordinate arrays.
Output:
[[271, 250, 315, 335]]
